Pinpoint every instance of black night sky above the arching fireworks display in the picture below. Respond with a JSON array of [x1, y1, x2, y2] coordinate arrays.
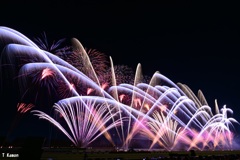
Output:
[[0, 0, 240, 141]]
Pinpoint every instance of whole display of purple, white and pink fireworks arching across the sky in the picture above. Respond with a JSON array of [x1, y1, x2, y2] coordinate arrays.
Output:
[[0, 27, 238, 151]]
